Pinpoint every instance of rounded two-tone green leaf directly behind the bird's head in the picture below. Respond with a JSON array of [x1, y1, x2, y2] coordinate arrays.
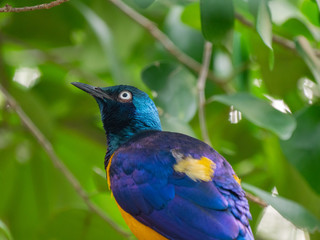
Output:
[[142, 62, 197, 122]]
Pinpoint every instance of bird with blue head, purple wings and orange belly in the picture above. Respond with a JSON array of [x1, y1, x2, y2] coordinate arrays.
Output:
[[72, 82, 254, 240]]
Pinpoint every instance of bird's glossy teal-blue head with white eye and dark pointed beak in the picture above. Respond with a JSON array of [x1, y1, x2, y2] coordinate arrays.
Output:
[[72, 82, 161, 146]]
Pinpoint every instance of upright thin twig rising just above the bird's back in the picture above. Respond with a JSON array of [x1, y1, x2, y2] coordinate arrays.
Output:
[[197, 41, 212, 145]]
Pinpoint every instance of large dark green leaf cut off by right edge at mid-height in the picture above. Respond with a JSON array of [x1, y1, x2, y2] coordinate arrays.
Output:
[[281, 106, 320, 194]]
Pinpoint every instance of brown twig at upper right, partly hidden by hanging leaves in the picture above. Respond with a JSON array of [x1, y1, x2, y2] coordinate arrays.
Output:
[[235, 13, 320, 57]]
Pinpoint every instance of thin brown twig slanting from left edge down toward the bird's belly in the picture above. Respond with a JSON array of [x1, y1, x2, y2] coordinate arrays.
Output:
[[0, 85, 130, 238]]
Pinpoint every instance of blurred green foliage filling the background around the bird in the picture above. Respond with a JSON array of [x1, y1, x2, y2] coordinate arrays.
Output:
[[0, 0, 320, 240]]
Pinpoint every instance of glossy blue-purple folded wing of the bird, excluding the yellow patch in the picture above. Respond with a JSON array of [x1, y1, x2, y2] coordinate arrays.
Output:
[[110, 136, 253, 240]]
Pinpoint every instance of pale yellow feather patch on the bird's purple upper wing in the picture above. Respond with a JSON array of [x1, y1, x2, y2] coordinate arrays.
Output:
[[171, 150, 216, 182]]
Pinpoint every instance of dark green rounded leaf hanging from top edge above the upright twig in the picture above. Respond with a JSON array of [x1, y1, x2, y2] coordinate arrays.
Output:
[[200, 0, 234, 42]]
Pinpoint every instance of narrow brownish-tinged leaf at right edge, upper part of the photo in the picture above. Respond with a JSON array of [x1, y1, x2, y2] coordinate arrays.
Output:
[[295, 36, 320, 85]]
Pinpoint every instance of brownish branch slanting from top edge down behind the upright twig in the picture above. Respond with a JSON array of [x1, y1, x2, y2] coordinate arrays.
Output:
[[109, 0, 230, 92]]
